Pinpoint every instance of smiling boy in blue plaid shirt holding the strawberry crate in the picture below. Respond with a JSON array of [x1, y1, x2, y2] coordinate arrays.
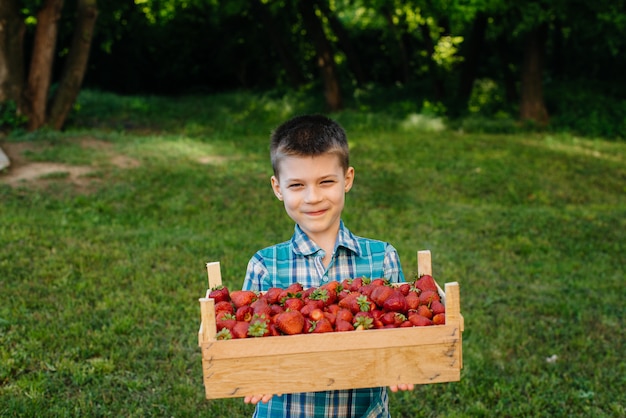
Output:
[[243, 115, 413, 418]]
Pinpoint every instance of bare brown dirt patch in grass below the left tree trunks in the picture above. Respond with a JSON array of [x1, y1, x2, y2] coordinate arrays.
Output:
[[0, 138, 139, 188]]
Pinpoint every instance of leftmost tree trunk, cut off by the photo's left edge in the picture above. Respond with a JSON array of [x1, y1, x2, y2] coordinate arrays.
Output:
[[0, 0, 26, 104]]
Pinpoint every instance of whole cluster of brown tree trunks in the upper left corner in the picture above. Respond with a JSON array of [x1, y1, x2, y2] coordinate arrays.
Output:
[[0, 0, 97, 131]]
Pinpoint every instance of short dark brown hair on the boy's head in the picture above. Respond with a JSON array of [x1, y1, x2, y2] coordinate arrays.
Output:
[[270, 115, 350, 177]]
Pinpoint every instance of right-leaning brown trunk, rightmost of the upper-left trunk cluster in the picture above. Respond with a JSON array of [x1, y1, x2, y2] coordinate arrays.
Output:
[[47, 0, 98, 130]]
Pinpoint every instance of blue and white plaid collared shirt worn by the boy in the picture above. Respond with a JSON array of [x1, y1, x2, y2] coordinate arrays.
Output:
[[243, 221, 404, 418]]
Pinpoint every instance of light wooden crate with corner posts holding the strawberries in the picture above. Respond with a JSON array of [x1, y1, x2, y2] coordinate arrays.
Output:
[[198, 251, 463, 399]]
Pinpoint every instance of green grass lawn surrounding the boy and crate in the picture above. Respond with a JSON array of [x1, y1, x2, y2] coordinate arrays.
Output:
[[0, 92, 626, 418]]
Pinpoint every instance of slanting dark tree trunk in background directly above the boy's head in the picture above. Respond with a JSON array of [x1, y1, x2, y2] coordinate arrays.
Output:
[[298, 0, 343, 111]]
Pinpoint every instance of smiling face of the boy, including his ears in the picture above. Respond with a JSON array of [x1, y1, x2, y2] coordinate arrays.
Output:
[[272, 154, 354, 244]]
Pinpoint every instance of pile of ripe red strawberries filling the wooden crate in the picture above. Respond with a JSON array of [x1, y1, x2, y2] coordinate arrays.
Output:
[[209, 275, 446, 340]]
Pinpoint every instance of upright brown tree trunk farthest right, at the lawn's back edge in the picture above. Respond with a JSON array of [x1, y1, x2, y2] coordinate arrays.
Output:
[[520, 24, 549, 126]]
